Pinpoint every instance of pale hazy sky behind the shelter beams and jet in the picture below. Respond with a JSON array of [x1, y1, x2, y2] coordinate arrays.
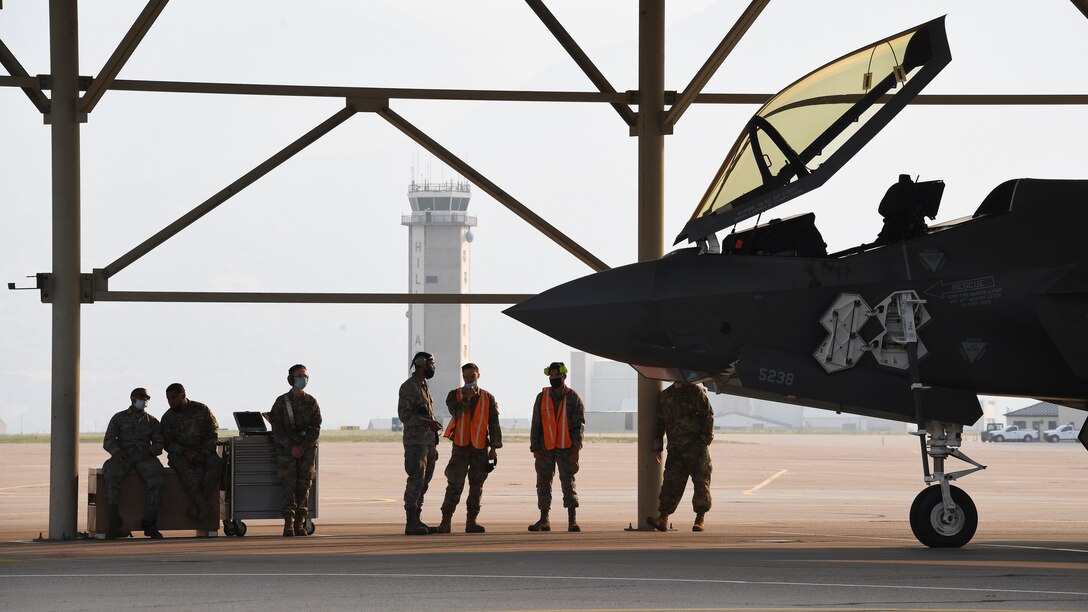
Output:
[[0, 0, 1088, 432]]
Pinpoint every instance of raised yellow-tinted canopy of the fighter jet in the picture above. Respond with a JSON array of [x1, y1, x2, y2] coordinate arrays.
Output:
[[676, 17, 952, 243]]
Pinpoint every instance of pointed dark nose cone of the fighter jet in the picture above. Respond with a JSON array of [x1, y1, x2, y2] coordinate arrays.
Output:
[[504, 264, 654, 363]]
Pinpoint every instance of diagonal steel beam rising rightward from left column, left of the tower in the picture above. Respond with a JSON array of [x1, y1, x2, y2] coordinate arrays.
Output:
[[102, 107, 356, 279]]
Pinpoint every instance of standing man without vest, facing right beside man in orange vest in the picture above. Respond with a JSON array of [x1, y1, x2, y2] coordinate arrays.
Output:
[[397, 352, 442, 536]]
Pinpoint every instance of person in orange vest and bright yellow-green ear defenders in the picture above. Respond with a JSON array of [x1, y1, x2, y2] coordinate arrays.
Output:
[[529, 362, 585, 531]]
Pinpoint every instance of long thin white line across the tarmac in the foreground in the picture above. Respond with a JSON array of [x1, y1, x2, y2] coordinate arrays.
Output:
[[0, 572, 1088, 597]]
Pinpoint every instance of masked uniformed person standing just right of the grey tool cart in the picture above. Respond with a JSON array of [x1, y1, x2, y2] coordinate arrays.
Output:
[[269, 364, 321, 536]]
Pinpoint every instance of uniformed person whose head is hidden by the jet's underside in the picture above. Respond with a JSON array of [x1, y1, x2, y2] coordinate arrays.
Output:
[[646, 382, 714, 531]]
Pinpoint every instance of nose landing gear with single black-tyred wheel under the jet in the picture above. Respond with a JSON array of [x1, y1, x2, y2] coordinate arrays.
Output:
[[911, 420, 986, 548]]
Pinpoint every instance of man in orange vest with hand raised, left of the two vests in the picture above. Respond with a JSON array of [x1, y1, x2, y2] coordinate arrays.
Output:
[[438, 364, 503, 534]]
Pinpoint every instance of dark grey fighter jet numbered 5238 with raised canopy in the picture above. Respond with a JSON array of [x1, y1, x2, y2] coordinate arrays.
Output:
[[506, 17, 1088, 547]]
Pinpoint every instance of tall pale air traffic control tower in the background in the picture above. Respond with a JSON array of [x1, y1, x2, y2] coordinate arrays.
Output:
[[400, 181, 477, 415]]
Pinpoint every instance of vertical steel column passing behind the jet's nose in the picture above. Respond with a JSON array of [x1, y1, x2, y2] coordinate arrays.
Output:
[[635, 0, 665, 529]]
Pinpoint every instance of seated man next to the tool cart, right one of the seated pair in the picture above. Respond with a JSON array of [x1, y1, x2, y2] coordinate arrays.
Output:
[[162, 382, 223, 521]]
